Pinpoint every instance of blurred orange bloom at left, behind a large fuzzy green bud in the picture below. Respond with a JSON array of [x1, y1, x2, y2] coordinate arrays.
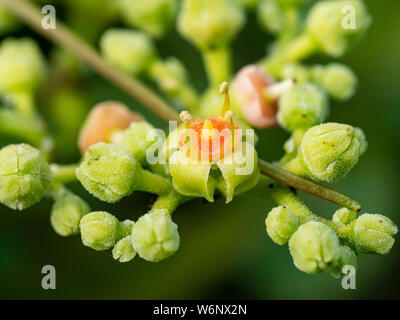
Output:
[[78, 101, 144, 154]]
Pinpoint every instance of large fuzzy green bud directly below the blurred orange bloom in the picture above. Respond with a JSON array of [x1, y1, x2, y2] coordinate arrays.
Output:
[[76, 142, 140, 203]]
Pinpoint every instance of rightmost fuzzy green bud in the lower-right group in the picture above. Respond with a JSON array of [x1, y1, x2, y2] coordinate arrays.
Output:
[[349, 213, 397, 254]]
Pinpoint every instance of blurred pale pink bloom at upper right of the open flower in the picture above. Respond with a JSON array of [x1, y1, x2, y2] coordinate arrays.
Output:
[[233, 65, 278, 128]]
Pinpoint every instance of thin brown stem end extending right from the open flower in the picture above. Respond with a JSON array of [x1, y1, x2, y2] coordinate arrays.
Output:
[[258, 159, 361, 212]]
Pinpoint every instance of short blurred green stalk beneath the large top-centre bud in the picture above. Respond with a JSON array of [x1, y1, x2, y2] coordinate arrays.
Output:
[[201, 46, 232, 88]]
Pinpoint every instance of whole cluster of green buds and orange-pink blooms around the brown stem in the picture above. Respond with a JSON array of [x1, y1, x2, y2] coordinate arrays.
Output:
[[0, 0, 397, 277]]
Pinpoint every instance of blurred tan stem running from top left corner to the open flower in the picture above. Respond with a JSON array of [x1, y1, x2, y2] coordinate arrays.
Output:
[[0, 0, 178, 121]]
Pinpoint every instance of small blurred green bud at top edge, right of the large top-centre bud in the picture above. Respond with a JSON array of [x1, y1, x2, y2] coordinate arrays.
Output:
[[257, 0, 285, 34]]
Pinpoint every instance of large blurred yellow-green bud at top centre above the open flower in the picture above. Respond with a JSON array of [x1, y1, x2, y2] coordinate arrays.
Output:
[[178, 0, 245, 48]]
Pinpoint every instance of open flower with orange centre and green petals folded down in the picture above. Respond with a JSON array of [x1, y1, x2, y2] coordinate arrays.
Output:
[[169, 82, 259, 202]]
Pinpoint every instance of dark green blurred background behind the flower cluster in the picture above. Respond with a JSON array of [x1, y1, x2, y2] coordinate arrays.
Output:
[[0, 0, 400, 299]]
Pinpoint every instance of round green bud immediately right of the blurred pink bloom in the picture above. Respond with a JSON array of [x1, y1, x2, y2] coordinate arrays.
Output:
[[278, 83, 328, 132]]
